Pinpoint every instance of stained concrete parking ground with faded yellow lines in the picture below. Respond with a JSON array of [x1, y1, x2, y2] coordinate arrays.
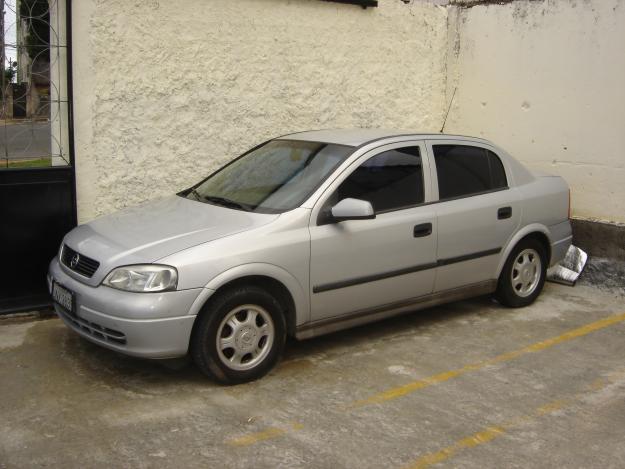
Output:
[[0, 262, 625, 469]]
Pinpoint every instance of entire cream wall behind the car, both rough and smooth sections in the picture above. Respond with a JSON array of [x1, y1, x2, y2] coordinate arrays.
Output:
[[73, 0, 625, 222]]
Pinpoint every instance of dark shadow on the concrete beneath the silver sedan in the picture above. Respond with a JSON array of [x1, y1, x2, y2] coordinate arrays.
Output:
[[57, 297, 501, 394]]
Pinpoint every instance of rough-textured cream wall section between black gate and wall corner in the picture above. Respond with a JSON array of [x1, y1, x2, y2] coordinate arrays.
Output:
[[73, 0, 447, 221]]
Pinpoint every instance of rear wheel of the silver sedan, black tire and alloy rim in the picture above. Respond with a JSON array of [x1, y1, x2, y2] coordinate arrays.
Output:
[[495, 238, 547, 308]]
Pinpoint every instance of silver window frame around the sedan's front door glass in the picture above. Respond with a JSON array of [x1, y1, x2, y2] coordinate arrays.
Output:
[[312, 140, 435, 225]]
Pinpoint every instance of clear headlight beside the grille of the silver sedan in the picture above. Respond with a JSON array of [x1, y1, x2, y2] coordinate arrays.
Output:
[[103, 264, 178, 292]]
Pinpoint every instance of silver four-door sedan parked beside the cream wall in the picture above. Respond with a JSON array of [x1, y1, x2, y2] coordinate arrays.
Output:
[[48, 130, 571, 383]]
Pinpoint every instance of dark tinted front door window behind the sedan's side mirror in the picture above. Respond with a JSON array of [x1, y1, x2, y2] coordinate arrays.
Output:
[[335, 147, 424, 213]]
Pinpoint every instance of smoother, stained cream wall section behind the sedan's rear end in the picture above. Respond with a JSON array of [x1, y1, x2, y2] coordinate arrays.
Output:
[[445, 0, 625, 222]]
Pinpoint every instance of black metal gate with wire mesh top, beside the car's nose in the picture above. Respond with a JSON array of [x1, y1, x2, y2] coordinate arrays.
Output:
[[0, 0, 76, 314]]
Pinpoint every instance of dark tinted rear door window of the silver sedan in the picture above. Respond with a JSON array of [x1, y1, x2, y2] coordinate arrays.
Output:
[[433, 145, 508, 200]]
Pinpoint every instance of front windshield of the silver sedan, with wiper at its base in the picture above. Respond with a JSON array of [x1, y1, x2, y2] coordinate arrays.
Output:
[[181, 140, 354, 213]]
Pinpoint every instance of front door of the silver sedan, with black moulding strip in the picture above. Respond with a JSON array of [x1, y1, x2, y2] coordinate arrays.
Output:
[[310, 142, 437, 322]]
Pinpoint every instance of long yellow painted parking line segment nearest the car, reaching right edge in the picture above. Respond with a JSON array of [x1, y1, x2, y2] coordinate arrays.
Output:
[[349, 313, 625, 407]]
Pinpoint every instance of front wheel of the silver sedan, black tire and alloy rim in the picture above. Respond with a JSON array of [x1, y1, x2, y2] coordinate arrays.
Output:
[[191, 286, 286, 384]]
